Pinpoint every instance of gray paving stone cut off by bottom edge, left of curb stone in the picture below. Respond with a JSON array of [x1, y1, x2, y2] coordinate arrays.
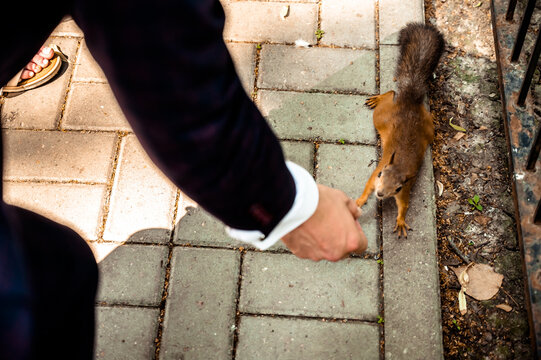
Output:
[[236, 316, 379, 360]]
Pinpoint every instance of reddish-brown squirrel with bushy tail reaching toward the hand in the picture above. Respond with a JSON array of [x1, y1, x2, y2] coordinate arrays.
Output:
[[356, 23, 445, 238]]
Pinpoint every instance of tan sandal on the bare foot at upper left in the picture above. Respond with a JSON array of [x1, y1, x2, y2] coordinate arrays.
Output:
[[0, 44, 68, 94]]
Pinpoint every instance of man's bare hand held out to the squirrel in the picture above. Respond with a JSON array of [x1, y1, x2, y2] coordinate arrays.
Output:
[[282, 185, 367, 261]]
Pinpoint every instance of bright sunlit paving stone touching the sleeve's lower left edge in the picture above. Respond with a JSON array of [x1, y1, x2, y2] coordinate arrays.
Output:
[[103, 135, 177, 241]]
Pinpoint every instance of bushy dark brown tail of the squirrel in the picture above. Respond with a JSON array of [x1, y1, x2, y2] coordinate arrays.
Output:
[[395, 23, 445, 103]]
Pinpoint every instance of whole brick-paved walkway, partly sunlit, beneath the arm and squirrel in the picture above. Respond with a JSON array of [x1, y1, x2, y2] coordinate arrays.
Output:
[[1, 0, 442, 359]]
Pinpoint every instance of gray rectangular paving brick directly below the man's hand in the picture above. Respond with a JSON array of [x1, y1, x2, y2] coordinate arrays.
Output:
[[239, 252, 379, 320]]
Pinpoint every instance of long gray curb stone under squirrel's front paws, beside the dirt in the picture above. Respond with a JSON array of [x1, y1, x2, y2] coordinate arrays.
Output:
[[383, 153, 443, 359]]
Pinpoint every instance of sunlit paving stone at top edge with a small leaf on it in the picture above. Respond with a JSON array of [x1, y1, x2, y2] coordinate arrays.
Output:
[[223, 1, 318, 44]]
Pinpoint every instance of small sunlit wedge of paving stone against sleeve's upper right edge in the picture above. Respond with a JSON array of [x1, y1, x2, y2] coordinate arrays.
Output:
[[226, 42, 256, 96]]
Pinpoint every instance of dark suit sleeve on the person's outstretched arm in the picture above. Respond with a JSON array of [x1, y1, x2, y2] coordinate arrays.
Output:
[[74, 0, 295, 234]]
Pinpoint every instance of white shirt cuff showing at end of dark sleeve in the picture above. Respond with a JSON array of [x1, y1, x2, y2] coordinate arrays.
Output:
[[226, 161, 319, 250]]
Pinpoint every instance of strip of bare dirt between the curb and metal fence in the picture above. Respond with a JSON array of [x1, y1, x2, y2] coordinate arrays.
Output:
[[425, 0, 533, 360]]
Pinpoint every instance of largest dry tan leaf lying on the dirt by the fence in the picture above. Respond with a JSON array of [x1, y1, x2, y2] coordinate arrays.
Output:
[[452, 263, 503, 300]]
